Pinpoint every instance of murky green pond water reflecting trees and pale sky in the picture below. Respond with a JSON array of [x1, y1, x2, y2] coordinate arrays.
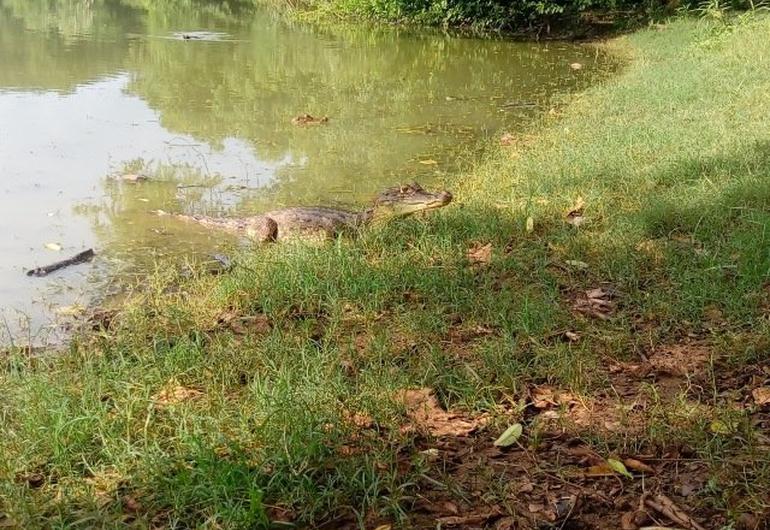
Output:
[[0, 0, 608, 342]]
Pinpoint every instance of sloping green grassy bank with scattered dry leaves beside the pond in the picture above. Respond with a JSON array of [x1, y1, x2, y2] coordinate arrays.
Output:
[[0, 11, 770, 529]]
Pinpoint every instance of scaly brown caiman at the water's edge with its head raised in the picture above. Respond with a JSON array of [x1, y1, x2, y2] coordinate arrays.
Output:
[[162, 182, 452, 242]]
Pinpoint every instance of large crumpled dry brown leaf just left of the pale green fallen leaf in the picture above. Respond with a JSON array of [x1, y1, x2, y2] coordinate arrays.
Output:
[[396, 388, 488, 438]]
